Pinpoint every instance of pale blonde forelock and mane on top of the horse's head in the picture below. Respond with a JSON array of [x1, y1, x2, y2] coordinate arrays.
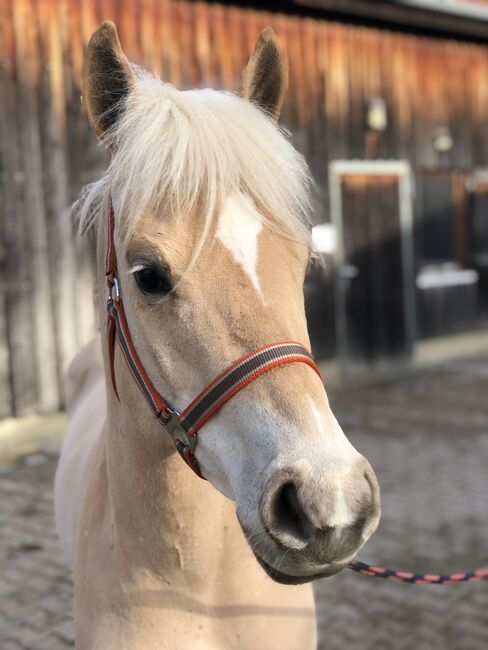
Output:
[[75, 70, 311, 248]]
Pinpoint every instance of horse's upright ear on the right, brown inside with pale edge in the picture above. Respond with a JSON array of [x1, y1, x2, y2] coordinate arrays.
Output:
[[241, 27, 288, 120]]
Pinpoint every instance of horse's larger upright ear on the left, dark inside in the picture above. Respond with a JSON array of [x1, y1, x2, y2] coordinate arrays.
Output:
[[82, 20, 136, 144]]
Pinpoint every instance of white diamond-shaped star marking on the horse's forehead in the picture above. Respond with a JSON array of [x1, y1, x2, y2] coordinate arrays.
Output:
[[217, 192, 263, 297]]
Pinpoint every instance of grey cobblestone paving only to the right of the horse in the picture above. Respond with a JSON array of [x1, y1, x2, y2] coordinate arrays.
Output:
[[315, 358, 488, 650]]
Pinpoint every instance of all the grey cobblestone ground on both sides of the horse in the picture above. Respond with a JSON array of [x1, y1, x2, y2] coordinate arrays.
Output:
[[0, 358, 488, 650]]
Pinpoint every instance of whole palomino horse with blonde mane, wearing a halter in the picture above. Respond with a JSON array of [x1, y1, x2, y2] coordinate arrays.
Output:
[[56, 22, 380, 650]]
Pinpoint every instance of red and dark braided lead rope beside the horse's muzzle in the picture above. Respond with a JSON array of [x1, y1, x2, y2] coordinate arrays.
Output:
[[348, 560, 488, 585]]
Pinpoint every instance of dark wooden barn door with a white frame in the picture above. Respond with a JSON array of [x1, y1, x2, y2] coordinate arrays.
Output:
[[330, 161, 415, 379]]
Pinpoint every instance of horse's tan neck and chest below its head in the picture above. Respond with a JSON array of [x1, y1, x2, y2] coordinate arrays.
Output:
[[81, 410, 316, 650]]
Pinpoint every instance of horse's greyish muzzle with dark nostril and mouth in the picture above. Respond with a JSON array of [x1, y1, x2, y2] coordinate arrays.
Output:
[[243, 455, 380, 584]]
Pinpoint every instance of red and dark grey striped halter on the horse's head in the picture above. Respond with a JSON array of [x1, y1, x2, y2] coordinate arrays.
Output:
[[106, 196, 320, 478]]
